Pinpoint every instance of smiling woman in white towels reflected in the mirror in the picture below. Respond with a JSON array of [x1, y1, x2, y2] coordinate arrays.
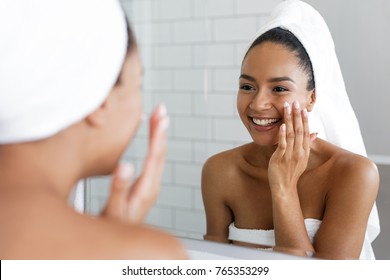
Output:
[[202, 1, 379, 259]]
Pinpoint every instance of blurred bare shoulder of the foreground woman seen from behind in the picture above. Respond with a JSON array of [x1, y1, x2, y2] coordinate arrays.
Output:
[[0, 194, 186, 259]]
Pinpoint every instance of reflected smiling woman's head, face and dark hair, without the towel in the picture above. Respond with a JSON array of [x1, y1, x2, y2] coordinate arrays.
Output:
[[237, 28, 315, 145]]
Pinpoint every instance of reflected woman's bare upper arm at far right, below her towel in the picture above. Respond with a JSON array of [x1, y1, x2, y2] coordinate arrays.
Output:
[[314, 154, 379, 259]]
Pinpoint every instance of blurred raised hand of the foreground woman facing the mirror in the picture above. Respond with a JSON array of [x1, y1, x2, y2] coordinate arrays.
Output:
[[102, 105, 169, 223]]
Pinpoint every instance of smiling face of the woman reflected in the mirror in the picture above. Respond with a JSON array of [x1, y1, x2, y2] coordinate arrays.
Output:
[[237, 42, 315, 146]]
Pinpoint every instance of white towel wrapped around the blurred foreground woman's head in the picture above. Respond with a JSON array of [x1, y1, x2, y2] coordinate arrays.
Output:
[[0, 0, 127, 144]]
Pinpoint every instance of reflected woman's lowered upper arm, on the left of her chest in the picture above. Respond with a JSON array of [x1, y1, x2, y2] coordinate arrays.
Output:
[[202, 155, 233, 243]]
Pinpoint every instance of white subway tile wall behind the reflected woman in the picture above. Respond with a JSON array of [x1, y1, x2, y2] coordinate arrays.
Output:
[[87, 0, 281, 238]]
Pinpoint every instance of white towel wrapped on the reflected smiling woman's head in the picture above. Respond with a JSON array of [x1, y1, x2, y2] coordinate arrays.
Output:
[[245, 0, 380, 255]]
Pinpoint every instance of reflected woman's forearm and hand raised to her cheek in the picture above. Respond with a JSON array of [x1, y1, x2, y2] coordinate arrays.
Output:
[[268, 101, 315, 254]]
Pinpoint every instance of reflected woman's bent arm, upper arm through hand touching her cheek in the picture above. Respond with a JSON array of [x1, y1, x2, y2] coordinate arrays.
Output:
[[268, 100, 379, 259]]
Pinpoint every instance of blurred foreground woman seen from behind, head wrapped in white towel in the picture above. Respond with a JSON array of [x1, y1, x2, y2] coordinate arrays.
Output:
[[0, 0, 185, 259]]
